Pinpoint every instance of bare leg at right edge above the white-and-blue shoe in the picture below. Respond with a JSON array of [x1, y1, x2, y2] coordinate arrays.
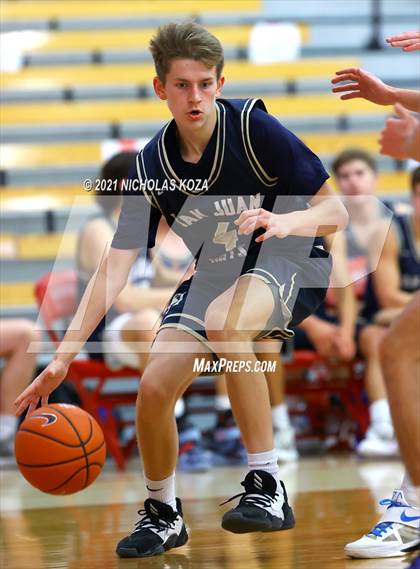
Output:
[[380, 294, 420, 486]]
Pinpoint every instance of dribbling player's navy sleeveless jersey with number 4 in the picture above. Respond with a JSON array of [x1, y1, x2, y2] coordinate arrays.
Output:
[[112, 99, 328, 274]]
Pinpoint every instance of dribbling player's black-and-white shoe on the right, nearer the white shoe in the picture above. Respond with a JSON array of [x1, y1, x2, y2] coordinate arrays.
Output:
[[221, 470, 295, 533]]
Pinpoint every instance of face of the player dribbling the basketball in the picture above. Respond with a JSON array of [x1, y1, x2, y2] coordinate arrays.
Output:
[[153, 59, 224, 130]]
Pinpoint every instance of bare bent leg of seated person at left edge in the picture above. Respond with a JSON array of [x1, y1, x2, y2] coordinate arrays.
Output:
[[0, 318, 40, 465]]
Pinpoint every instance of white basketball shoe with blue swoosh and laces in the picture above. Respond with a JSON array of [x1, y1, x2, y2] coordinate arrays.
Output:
[[344, 489, 420, 559]]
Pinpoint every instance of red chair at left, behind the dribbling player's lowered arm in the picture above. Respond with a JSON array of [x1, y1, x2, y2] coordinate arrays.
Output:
[[35, 271, 139, 470]]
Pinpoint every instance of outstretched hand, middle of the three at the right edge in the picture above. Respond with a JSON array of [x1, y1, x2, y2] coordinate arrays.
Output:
[[331, 67, 393, 105]]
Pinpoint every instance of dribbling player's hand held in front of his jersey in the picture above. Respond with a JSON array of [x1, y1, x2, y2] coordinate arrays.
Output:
[[234, 211, 292, 243]]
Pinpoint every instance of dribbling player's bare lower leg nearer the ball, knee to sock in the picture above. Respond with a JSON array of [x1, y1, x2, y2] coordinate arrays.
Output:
[[137, 329, 211, 480]]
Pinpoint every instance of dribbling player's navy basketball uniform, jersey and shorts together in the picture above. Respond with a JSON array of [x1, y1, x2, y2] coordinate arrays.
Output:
[[112, 99, 331, 340]]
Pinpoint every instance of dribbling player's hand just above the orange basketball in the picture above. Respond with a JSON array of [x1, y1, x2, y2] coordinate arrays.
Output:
[[14, 359, 68, 415]]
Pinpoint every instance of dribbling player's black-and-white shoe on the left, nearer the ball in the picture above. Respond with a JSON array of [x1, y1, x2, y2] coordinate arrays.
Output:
[[116, 498, 188, 557]]
